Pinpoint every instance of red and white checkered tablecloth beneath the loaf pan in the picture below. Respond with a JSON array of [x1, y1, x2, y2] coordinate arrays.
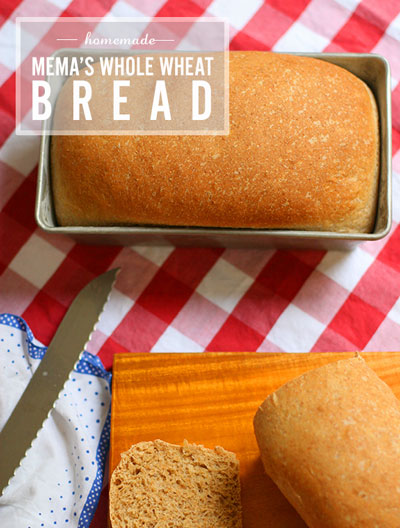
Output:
[[0, 0, 400, 527]]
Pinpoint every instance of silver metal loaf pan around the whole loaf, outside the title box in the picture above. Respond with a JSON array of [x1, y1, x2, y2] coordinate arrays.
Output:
[[36, 50, 392, 249]]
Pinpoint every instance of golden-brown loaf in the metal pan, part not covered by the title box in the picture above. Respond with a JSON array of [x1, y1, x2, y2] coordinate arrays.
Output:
[[51, 51, 379, 232]]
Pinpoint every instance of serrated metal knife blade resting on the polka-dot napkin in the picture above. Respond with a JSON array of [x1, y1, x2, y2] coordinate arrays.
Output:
[[0, 268, 119, 495]]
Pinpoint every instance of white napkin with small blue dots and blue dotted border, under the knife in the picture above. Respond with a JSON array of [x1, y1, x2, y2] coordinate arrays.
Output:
[[0, 314, 111, 528]]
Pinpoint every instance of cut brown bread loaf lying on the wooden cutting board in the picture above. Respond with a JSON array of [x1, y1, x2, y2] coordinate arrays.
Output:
[[254, 357, 400, 528]]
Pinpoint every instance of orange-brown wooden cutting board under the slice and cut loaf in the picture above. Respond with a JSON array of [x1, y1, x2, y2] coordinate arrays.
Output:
[[110, 352, 400, 528]]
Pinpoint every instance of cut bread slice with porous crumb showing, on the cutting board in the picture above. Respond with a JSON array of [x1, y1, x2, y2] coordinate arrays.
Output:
[[110, 440, 242, 528]]
